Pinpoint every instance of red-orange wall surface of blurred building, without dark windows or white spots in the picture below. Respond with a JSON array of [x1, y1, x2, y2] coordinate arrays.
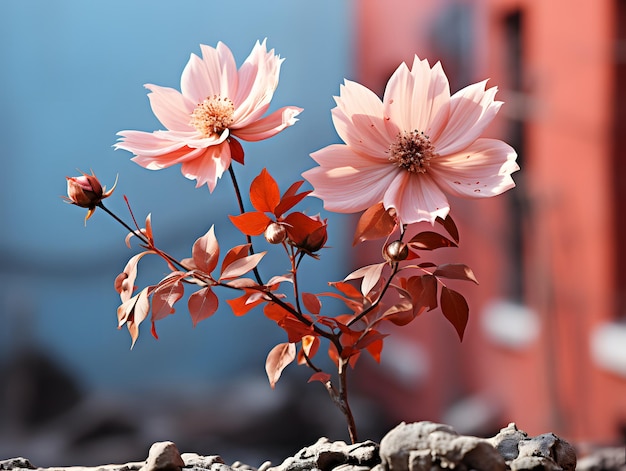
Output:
[[356, 0, 626, 441]]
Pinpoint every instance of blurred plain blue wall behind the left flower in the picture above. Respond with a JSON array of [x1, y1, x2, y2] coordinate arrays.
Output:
[[0, 0, 354, 390]]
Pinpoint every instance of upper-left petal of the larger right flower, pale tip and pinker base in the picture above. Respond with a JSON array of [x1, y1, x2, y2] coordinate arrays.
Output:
[[332, 80, 398, 158]]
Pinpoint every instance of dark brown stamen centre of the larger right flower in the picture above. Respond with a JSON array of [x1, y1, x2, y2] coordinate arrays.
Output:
[[389, 130, 437, 173]]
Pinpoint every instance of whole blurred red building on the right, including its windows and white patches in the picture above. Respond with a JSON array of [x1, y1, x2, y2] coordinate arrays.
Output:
[[355, 0, 626, 443]]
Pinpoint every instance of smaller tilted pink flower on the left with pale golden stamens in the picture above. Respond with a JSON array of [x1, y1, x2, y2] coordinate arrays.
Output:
[[115, 41, 302, 191]]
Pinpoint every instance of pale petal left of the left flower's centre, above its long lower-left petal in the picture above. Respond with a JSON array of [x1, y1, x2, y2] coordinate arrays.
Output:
[[145, 84, 195, 131]]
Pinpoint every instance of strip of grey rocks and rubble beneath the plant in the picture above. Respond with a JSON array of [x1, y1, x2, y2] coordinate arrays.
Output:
[[0, 422, 626, 471]]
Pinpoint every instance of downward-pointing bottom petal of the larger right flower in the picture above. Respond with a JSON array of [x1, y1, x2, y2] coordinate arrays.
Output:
[[383, 171, 450, 224]]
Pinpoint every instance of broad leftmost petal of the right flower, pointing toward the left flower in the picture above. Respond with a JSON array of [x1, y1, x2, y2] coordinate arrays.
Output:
[[302, 144, 399, 213]]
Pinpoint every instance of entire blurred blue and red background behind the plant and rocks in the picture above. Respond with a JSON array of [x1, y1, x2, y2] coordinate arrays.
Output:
[[0, 0, 626, 466]]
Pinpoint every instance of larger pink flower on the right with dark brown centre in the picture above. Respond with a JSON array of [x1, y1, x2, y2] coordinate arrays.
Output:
[[302, 56, 519, 224]]
